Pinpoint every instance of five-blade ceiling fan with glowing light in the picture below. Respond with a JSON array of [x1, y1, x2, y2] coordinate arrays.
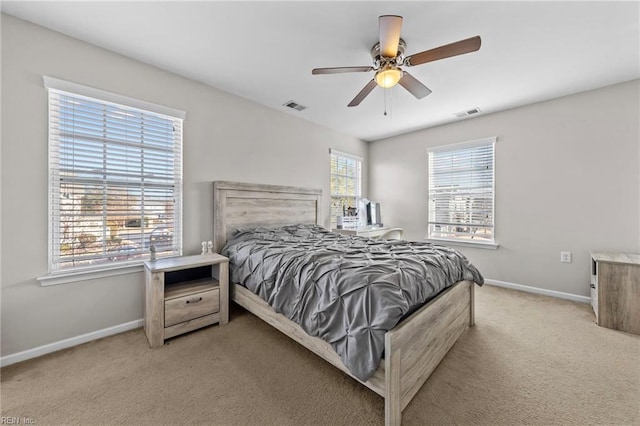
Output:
[[311, 15, 481, 107]]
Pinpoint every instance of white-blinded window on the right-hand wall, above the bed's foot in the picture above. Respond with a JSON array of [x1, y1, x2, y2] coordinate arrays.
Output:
[[427, 138, 496, 245]]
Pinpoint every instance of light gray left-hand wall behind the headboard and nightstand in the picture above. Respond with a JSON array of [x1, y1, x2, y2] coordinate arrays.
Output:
[[0, 15, 367, 356]]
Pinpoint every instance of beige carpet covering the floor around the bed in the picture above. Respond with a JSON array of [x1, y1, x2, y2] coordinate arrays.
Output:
[[0, 286, 640, 425]]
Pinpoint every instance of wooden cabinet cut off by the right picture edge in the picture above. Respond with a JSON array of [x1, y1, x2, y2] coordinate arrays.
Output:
[[591, 252, 640, 334]]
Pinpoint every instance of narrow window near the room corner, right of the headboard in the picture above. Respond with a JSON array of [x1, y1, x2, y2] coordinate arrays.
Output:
[[331, 149, 362, 228]]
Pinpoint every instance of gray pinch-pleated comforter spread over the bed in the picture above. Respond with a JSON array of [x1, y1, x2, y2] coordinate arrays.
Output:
[[222, 225, 484, 381]]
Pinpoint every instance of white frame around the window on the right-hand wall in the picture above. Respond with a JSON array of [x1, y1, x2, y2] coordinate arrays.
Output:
[[426, 137, 499, 249]]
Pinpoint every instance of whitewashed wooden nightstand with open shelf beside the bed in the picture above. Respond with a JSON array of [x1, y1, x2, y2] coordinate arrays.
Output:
[[144, 254, 229, 348]]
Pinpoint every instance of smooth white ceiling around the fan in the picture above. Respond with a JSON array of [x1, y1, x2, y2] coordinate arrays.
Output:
[[2, 1, 640, 141]]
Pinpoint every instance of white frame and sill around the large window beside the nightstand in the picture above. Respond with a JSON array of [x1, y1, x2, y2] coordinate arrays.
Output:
[[38, 76, 186, 286]]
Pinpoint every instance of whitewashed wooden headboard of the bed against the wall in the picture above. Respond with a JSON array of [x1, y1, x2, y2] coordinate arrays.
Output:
[[213, 181, 322, 253]]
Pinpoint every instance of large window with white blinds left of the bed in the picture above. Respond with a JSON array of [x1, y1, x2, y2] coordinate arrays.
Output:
[[44, 77, 184, 272]]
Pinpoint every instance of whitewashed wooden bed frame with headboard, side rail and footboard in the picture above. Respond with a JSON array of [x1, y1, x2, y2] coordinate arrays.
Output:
[[213, 181, 474, 426]]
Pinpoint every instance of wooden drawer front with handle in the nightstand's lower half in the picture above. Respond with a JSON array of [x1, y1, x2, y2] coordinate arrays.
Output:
[[164, 288, 220, 327]]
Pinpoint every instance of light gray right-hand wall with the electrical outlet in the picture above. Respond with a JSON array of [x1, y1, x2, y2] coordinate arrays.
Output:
[[369, 80, 640, 296]]
